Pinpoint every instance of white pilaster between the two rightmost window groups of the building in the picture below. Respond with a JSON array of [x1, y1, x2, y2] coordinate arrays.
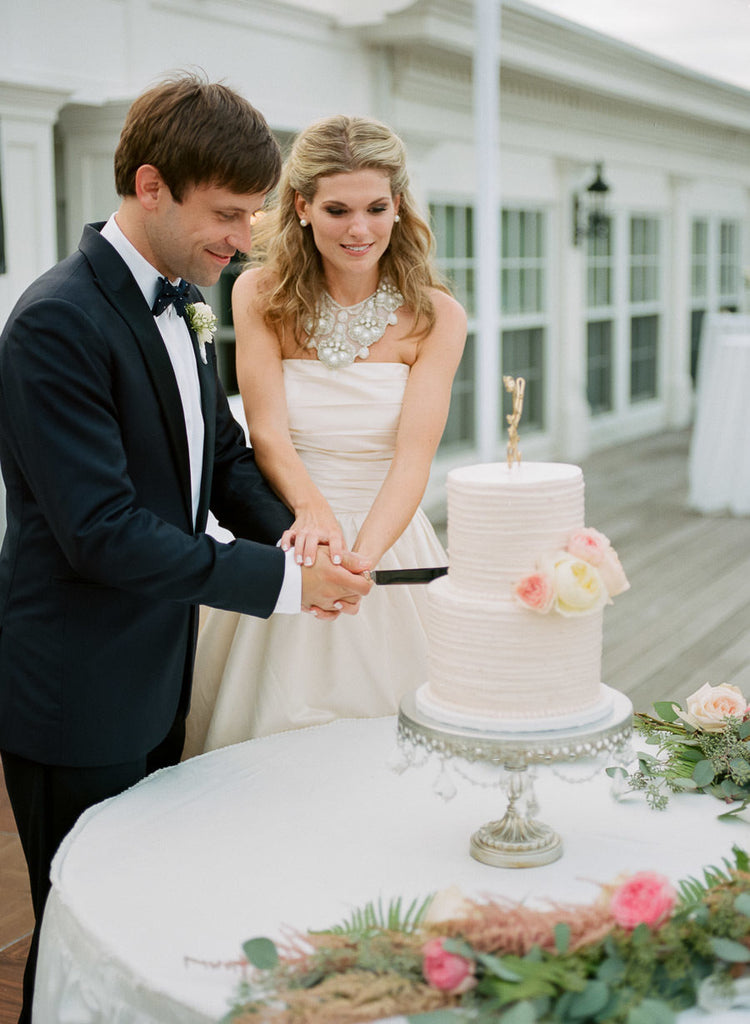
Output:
[[663, 175, 693, 427]]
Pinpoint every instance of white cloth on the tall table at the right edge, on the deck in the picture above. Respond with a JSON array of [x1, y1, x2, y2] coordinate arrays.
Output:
[[688, 313, 750, 515]]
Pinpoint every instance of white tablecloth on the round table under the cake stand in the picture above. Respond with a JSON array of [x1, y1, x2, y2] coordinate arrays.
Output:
[[34, 718, 749, 1024]]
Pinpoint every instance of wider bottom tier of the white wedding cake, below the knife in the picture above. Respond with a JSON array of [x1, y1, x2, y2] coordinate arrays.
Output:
[[424, 577, 602, 721]]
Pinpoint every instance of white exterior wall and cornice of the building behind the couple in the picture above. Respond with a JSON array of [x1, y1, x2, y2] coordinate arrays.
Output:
[[0, 0, 750, 528]]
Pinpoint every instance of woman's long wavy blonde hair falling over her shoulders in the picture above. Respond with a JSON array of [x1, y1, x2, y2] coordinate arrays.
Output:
[[249, 115, 448, 342]]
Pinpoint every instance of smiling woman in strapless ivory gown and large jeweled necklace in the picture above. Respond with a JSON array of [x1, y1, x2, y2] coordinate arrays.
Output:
[[185, 117, 466, 756]]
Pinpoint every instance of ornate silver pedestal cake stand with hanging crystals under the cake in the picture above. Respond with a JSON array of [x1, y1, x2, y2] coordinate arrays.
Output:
[[399, 687, 633, 867]]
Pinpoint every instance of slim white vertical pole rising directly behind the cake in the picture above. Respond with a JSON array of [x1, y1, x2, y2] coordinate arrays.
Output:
[[473, 0, 502, 462]]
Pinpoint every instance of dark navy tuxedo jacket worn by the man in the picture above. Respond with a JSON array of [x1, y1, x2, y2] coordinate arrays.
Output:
[[0, 225, 292, 766]]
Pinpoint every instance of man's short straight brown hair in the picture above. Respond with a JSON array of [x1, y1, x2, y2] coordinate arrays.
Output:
[[115, 74, 281, 203]]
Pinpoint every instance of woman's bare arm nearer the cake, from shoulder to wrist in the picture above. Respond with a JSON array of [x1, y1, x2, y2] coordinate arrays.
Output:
[[352, 292, 466, 565]]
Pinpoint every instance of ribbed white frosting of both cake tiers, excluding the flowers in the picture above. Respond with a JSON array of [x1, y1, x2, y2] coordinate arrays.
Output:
[[417, 463, 601, 729]]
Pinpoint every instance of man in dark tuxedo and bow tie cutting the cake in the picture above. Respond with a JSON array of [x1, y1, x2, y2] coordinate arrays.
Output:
[[0, 76, 370, 1022]]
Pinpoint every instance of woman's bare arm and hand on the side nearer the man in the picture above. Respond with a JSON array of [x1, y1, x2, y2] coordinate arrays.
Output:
[[232, 270, 345, 565]]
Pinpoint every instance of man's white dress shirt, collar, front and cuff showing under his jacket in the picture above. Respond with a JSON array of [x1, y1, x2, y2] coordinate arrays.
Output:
[[101, 213, 302, 614]]
